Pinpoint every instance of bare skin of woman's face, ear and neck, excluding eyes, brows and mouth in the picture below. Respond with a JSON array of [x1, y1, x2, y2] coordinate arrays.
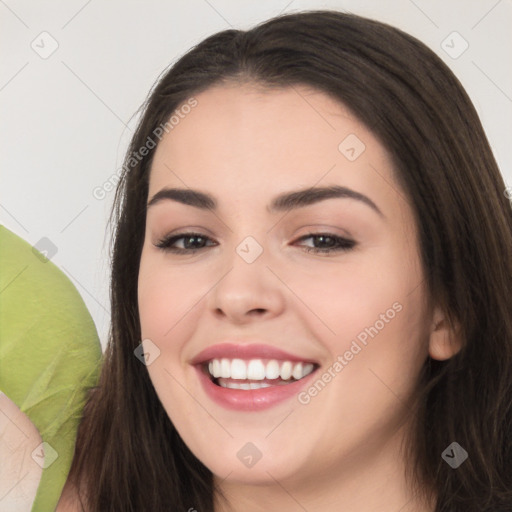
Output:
[[138, 84, 460, 512]]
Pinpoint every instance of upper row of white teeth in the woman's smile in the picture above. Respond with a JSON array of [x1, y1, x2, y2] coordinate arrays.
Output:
[[208, 358, 313, 380]]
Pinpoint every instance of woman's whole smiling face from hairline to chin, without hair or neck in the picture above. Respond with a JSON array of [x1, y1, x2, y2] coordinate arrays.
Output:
[[138, 85, 431, 488]]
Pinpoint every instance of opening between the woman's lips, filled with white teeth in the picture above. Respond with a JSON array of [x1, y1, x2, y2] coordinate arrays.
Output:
[[202, 358, 319, 390]]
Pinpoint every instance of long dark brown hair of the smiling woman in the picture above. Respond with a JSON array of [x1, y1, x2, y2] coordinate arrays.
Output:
[[70, 10, 512, 512]]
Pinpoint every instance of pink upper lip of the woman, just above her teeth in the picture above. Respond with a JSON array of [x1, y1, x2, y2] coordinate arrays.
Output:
[[191, 343, 316, 365]]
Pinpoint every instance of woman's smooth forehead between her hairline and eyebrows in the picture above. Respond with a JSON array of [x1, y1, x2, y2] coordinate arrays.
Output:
[[150, 84, 391, 204]]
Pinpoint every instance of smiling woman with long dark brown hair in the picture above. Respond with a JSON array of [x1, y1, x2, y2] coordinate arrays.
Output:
[[61, 11, 512, 512]]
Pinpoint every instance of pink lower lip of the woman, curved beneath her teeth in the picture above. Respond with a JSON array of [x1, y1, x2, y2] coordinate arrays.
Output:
[[195, 365, 316, 411]]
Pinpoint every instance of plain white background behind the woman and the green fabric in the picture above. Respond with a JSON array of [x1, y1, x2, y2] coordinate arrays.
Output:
[[0, 0, 512, 346]]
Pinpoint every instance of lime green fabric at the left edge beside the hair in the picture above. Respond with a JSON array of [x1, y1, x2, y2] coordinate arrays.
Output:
[[0, 225, 102, 512]]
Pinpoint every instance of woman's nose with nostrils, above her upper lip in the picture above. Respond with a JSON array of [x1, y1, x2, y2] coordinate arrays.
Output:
[[209, 243, 285, 324]]
